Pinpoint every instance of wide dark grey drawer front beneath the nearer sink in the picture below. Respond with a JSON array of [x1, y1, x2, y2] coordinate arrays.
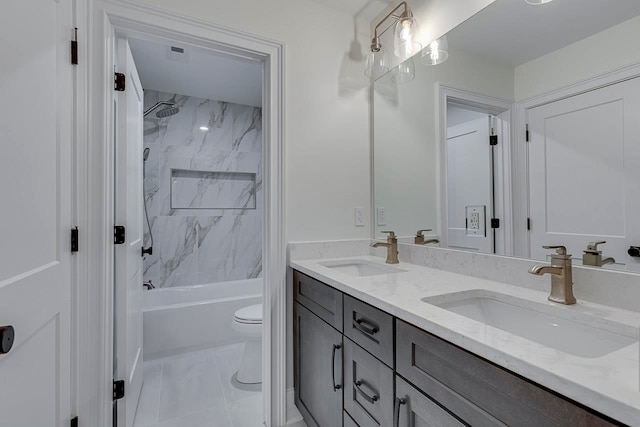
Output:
[[396, 320, 616, 427]]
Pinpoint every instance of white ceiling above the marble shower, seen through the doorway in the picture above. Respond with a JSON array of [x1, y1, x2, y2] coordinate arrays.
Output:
[[129, 38, 262, 107]]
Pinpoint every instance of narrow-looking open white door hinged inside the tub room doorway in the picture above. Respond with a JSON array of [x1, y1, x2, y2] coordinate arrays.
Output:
[[114, 38, 144, 427]]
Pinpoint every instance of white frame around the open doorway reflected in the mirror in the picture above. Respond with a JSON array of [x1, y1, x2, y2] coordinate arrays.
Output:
[[436, 83, 514, 255]]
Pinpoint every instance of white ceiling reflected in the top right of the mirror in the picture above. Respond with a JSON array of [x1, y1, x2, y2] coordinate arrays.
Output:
[[447, 0, 640, 66]]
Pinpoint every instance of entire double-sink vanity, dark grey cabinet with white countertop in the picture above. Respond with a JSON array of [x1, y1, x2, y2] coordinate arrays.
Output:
[[290, 251, 640, 427]]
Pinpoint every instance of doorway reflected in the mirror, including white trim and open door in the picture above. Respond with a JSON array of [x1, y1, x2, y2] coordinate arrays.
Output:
[[439, 86, 511, 255]]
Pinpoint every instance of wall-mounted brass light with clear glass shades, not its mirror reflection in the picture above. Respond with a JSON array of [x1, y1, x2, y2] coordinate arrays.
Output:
[[364, 1, 422, 78]]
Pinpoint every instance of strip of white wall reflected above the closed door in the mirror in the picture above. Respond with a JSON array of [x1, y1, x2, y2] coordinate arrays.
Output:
[[515, 16, 640, 101]]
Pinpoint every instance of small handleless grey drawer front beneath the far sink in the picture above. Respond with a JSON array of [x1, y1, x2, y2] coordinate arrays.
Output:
[[293, 270, 342, 332]]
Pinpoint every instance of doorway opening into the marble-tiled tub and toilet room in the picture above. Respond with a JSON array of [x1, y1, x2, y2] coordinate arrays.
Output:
[[114, 34, 264, 427]]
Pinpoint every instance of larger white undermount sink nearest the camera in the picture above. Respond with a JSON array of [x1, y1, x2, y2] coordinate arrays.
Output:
[[422, 289, 638, 358]]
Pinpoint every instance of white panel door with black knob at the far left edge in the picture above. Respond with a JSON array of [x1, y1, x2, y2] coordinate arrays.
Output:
[[0, 0, 73, 427]]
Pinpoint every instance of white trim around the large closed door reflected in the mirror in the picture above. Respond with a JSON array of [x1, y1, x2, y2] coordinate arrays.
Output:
[[512, 63, 640, 258]]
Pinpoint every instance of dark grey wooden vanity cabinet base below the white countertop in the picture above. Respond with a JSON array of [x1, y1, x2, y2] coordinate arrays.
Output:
[[293, 270, 622, 427]]
